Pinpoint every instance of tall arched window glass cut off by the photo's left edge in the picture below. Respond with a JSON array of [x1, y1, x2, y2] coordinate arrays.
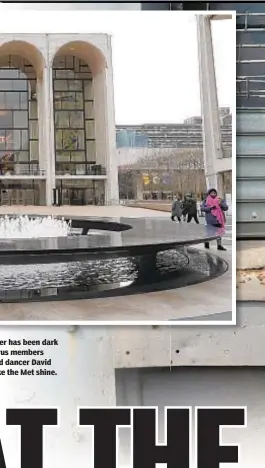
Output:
[[0, 56, 39, 175]]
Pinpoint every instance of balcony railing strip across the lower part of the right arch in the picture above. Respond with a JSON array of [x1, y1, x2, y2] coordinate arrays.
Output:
[[55, 161, 106, 176]]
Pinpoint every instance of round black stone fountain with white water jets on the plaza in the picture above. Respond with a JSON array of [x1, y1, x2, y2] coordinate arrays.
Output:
[[0, 215, 227, 302]]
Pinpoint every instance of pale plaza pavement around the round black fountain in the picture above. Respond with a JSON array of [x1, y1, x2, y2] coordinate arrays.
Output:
[[0, 206, 232, 324]]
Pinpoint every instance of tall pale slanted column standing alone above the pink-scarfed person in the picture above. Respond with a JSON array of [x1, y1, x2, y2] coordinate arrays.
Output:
[[197, 15, 223, 194]]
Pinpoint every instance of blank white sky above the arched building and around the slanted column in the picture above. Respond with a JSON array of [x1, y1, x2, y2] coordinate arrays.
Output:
[[0, 5, 236, 124]]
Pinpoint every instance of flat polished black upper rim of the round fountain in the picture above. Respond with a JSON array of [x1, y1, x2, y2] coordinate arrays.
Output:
[[0, 213, 220, 265]]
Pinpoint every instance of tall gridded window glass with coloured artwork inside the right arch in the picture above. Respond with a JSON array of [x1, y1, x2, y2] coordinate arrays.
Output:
[[53, 56, 96, 174]]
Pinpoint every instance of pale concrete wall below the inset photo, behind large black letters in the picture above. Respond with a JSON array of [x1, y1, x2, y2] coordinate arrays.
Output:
[[0, 307, 260, 468]]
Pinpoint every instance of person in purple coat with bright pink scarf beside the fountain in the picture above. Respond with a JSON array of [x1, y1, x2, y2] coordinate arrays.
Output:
[[201, 189, 228, 250]]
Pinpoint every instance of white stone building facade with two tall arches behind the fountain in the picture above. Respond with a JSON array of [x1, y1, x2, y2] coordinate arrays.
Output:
[[0, 34, 119, 205]]
